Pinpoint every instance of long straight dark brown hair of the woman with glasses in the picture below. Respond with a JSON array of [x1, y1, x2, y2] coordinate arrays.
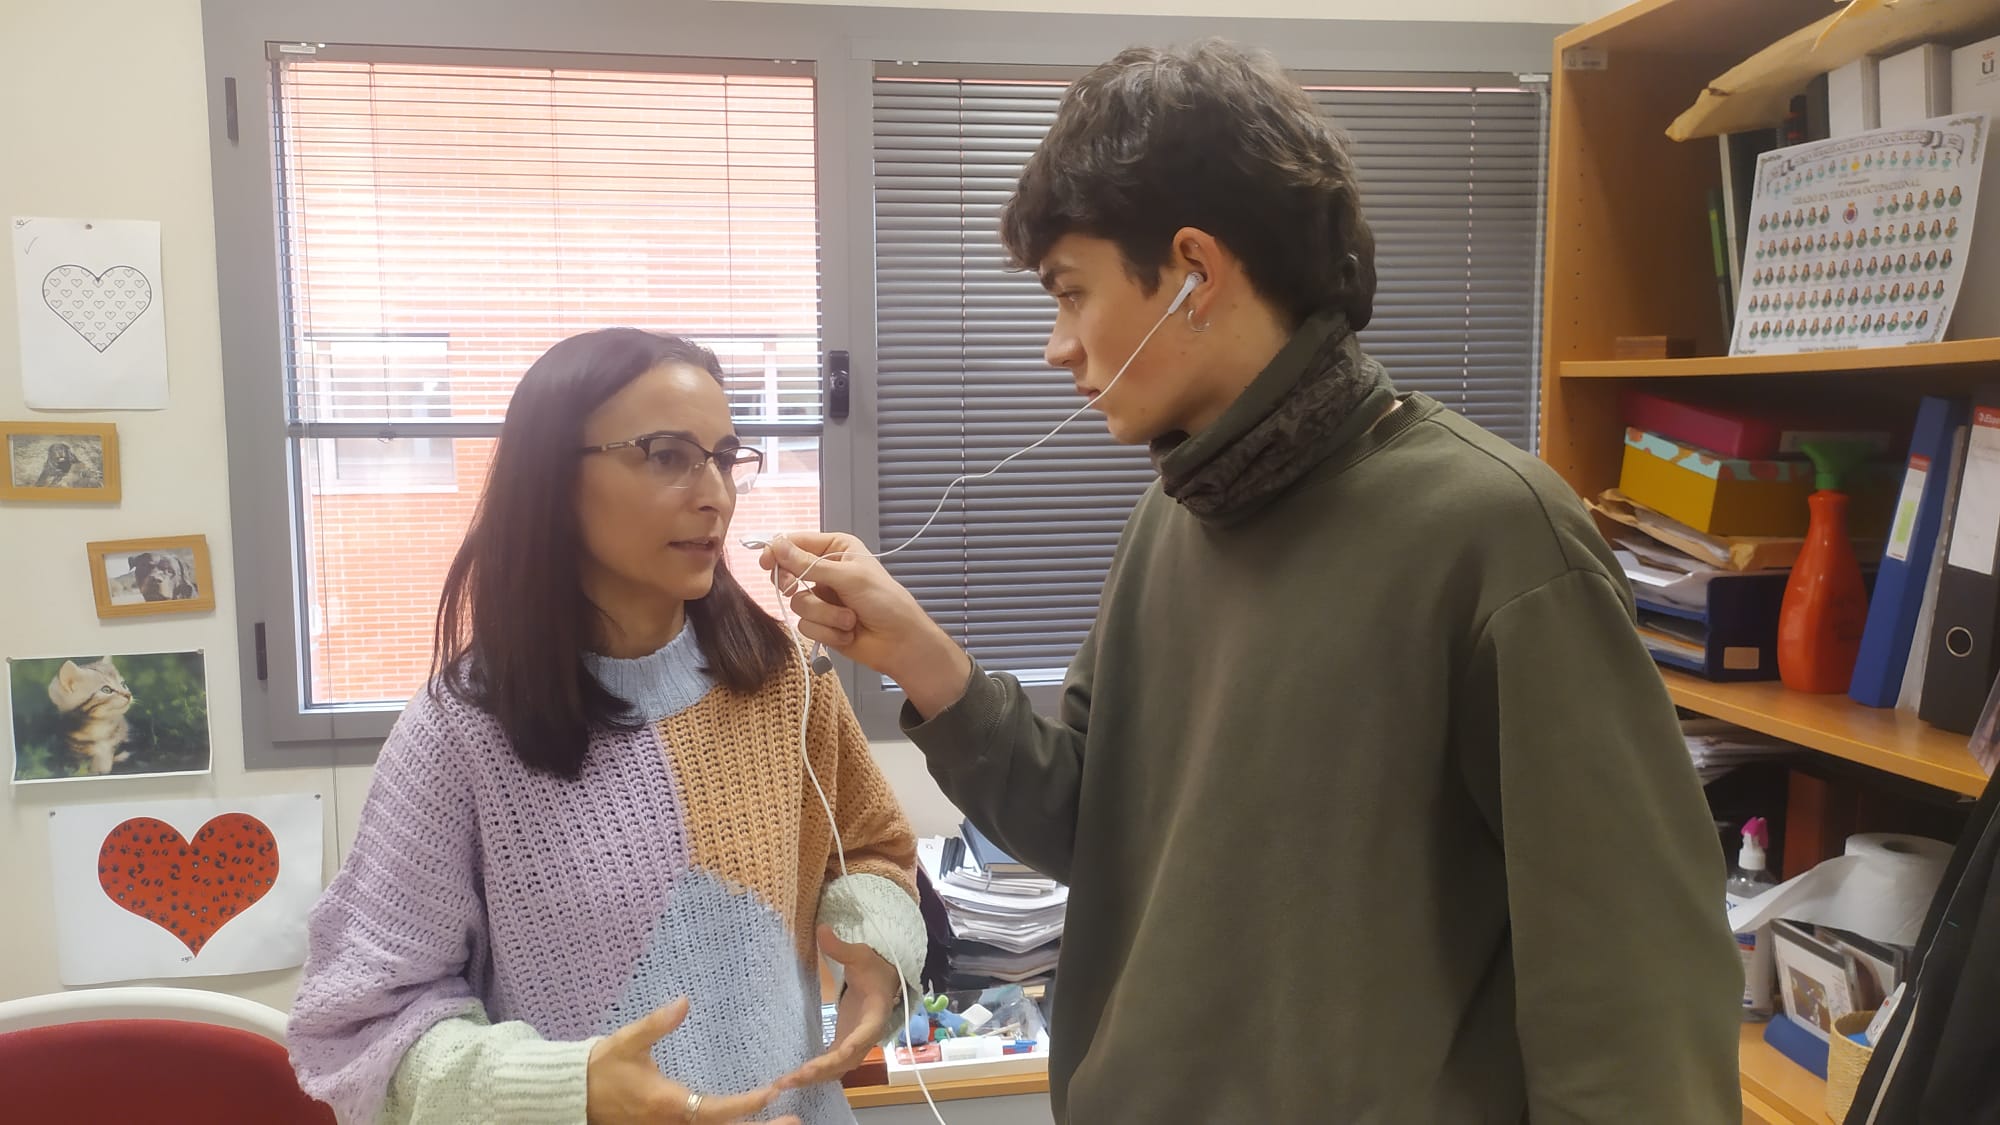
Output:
[[430, 328, 792, 779]]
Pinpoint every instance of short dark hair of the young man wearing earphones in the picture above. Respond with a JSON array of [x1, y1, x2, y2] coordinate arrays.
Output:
[[1000, 40, 1376, 330]]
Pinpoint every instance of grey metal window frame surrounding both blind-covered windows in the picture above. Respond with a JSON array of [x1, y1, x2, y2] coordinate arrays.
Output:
[[202, 0, 1564, 769]]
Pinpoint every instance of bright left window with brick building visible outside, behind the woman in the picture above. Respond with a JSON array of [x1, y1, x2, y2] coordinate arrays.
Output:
[[272, 48, 820, 707]]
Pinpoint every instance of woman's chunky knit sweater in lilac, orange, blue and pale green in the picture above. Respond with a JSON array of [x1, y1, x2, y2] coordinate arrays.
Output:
[[288, 631, 924, 1125]]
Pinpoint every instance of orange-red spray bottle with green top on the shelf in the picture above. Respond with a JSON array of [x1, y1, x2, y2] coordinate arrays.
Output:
[[1778, 442, 1868, 695]]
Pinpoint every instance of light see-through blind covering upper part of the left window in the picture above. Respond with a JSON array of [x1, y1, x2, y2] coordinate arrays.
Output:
[[276, 52, 820, 434]]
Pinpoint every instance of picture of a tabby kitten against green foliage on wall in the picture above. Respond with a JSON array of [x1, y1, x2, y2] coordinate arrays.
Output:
[[8, 653, 210, 785]]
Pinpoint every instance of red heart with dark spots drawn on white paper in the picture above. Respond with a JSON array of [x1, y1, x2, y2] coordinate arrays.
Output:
[[98, 813, 278, 955]]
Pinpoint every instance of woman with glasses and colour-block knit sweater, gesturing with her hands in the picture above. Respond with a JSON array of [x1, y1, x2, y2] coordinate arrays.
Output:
[[290, 328, 926, 1125]]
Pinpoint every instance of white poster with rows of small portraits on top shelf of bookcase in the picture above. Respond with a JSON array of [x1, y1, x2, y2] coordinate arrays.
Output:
[[1730, 114, 1988, 356]]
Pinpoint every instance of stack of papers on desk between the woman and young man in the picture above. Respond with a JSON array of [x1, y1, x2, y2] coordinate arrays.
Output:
[[916, 837, 1070, 987]]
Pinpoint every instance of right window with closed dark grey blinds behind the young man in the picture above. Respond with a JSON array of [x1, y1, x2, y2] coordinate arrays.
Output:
[[874, 74, 1544, 683]]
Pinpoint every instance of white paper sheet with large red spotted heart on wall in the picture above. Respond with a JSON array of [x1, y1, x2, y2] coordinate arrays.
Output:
[[48, 793, 324, 987]]
